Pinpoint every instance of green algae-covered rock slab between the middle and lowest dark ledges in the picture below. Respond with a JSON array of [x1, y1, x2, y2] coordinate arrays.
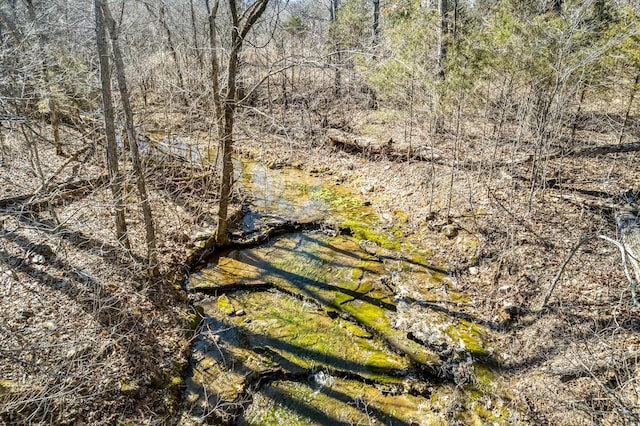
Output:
[[186, 291, 416, 421]]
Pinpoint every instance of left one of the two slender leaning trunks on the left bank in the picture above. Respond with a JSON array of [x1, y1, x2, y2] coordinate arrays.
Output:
[[93, 0, 131, 250]]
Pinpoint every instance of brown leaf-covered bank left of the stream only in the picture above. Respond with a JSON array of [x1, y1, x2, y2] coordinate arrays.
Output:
[[0, 125, 200, 425]]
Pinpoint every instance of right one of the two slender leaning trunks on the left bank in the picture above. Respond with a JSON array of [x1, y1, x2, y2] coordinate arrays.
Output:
[[98, 0, 158, 275]]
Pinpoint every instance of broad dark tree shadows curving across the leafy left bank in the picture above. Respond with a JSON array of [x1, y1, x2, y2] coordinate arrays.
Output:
[[0, 213, 182, 422]]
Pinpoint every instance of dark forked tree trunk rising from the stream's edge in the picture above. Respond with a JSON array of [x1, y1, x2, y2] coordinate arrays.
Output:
[[214, 0, 269, 244]]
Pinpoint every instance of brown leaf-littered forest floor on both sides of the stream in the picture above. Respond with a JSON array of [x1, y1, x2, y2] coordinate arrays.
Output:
[[0, 102, 640, 424]]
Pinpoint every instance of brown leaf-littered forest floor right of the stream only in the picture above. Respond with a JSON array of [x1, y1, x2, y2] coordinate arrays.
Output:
[[230, 104, 640, 425]]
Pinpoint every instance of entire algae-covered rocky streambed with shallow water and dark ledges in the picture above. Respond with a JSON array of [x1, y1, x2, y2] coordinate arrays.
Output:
[[179, 163, 518, 425]]
